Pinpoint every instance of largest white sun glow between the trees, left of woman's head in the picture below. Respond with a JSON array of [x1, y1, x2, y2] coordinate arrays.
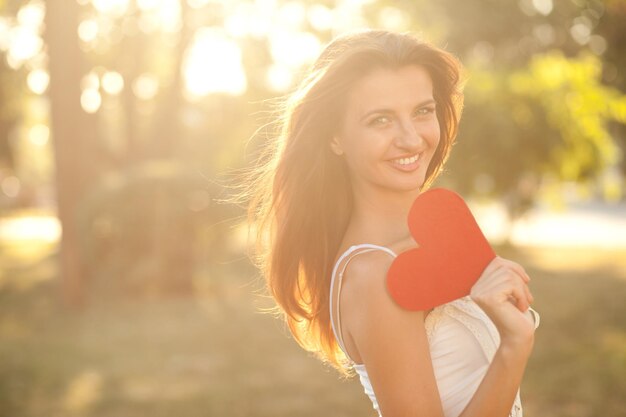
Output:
[[183, 28, 248, 100]]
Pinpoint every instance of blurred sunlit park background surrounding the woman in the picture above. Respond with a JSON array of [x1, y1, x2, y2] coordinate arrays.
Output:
[[0, 0, 626, 417]]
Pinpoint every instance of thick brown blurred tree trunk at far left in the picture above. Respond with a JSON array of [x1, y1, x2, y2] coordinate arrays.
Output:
[[45, 0, 97, 307]]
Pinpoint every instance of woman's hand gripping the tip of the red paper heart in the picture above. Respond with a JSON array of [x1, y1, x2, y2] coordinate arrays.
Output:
[[470, 257, 535, 346]]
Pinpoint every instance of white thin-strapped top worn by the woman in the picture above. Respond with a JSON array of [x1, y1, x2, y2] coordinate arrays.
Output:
[[329, 244, 539, 417]]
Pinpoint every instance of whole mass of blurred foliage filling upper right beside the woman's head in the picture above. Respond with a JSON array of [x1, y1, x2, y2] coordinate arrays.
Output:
[[371, 0, 626, 208]]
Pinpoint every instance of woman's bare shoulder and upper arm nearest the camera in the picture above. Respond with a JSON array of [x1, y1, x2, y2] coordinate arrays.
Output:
[[344, 253, 444, 417]]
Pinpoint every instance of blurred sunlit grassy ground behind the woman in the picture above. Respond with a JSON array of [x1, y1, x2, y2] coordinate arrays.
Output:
[[0, 236, 626, 417]]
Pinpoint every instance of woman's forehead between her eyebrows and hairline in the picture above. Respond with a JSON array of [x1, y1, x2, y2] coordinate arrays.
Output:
[[346, 65, 433, 113]]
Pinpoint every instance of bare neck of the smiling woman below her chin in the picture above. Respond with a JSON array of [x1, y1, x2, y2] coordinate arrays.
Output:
[[346, 180, 420, 246]]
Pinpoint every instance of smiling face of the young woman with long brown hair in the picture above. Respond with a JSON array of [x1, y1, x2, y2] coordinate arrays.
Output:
[[331, 65, 440, 191]]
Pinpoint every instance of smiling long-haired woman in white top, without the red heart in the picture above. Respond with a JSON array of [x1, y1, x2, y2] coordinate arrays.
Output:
[[244, 31, 538, 417]]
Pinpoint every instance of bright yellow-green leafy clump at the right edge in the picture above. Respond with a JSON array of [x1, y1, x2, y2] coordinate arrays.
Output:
[[509, 52, 626, 181]]
